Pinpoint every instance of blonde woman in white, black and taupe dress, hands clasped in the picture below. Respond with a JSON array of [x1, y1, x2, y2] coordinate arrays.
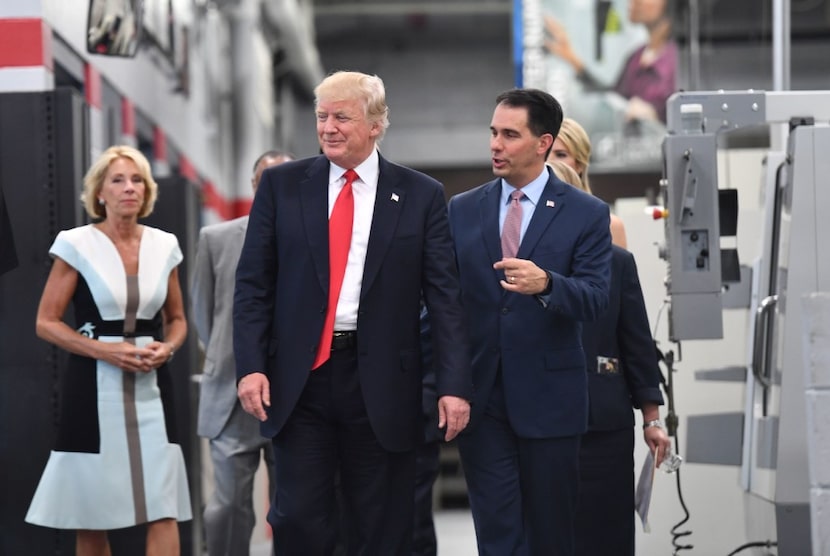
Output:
[[26, 146, 191, 556]]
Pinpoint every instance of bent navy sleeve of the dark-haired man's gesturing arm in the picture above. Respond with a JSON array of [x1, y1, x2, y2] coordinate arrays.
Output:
[[546, 199, 611, 321]]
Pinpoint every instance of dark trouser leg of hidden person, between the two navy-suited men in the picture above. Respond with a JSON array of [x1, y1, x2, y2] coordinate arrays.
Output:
[[412, 441, 441, 556]]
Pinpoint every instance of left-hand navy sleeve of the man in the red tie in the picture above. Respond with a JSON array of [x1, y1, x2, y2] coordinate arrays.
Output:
[[233, 172, 277, 380]]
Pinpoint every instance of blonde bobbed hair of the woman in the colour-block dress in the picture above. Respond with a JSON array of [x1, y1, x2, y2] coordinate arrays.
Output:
[[81, 145, 158, 220]]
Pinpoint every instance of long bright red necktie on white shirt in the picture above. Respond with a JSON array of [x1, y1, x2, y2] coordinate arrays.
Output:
[[311, 170, 357, 370]]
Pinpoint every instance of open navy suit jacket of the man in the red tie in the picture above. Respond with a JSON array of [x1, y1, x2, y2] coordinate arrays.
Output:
[[234, 152, 472, 451]]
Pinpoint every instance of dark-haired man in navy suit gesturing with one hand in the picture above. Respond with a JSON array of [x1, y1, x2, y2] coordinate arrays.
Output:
[[449, 89, 611, 556]]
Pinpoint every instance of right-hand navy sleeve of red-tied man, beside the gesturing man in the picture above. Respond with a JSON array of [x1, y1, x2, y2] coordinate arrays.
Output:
[[422, 187, 473, 400]]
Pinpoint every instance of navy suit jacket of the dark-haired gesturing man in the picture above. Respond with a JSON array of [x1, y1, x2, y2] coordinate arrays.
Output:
[[448, 172, 611, 438]]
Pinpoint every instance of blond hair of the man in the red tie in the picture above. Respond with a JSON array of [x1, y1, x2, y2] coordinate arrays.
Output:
[[314, 71, 389, 142]]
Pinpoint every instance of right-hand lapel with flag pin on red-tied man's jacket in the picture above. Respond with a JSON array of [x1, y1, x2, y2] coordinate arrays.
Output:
[[360, 156, 406, 299]]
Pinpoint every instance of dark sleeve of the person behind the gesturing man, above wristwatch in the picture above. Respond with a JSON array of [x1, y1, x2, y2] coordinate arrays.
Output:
[[617, 252, 663, 408]]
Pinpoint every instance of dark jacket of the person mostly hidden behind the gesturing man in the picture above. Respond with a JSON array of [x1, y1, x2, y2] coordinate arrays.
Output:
[[582, 246, 663, 430]]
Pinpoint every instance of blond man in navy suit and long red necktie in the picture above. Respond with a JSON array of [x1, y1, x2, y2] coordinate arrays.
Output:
[[234, 72, 472, 556]]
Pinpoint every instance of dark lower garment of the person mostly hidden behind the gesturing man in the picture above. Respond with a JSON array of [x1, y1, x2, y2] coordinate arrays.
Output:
[[576, 428, 634, 556]]
